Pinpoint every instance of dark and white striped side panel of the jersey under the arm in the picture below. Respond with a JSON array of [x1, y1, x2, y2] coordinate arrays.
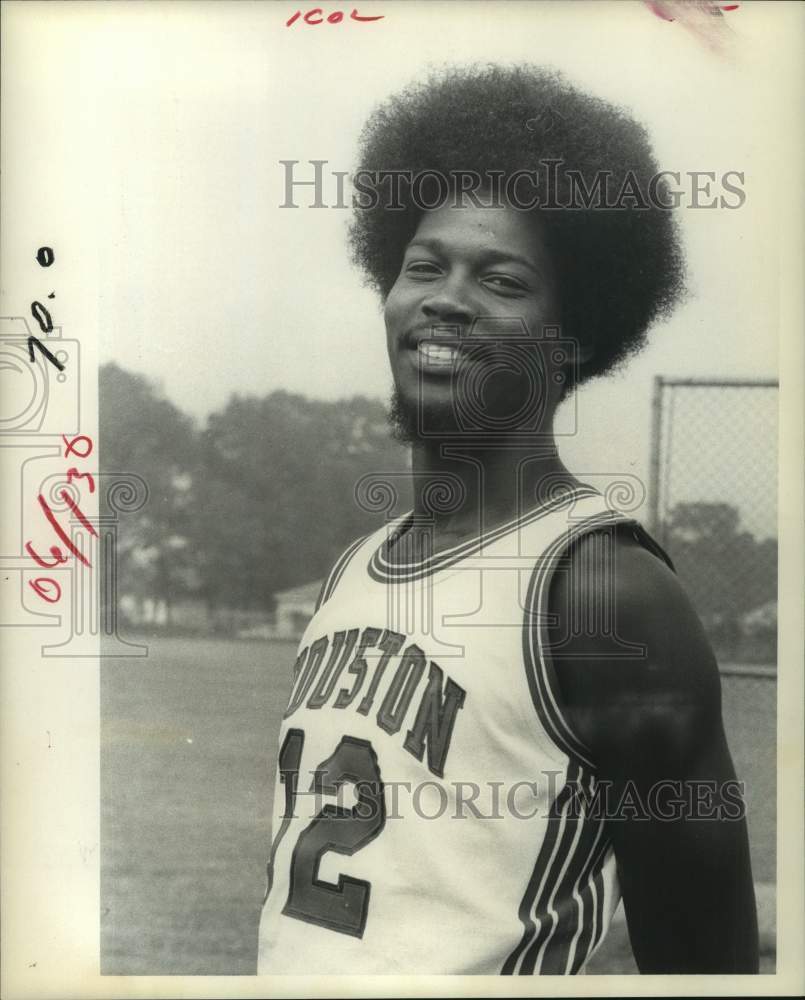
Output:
[[501, 762, 610, 976]]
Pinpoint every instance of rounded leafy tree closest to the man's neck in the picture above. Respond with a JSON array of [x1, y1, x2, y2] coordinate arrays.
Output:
[[198, 391, 407, 606]]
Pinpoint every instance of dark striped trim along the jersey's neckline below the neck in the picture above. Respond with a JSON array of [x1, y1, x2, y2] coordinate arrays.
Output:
[[367, 485, 602, 583]]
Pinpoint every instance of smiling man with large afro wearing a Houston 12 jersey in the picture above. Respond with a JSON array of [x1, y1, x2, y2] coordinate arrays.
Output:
[[259, 67, 757, 974]]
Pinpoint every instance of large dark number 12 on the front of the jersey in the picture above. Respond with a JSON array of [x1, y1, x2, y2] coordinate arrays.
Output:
[[264, 729, 386, 937]]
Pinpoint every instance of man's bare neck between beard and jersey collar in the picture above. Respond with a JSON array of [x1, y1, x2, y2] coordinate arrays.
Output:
[[412, 433, 578, 533]]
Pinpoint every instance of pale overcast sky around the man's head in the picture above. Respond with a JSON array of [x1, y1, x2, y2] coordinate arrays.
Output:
[[7, 0, 779, 540]]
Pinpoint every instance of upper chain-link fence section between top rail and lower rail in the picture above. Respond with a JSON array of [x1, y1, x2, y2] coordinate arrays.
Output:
[[650, 377, 777, 667]]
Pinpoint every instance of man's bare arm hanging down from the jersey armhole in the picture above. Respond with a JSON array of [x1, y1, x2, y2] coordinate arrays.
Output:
[[550, 536, 758, 973]]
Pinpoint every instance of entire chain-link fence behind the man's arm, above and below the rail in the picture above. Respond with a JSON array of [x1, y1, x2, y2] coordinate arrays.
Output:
[[649, 377, 778, 883]]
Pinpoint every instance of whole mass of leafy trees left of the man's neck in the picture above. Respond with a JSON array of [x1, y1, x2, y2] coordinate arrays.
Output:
[[100, 364, 410, 619]]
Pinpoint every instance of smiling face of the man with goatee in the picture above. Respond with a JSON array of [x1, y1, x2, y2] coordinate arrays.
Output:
[[385, 199, 562, 440]]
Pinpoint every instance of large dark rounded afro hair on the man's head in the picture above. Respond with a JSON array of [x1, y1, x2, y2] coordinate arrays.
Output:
[[349, 65, 684, 391]]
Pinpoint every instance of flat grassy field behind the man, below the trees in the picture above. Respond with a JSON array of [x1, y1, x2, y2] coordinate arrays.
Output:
[[101, 637, 776, 975]]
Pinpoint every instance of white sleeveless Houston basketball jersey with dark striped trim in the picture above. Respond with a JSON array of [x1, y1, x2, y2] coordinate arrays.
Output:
[[258, 487, 672, 975]]
